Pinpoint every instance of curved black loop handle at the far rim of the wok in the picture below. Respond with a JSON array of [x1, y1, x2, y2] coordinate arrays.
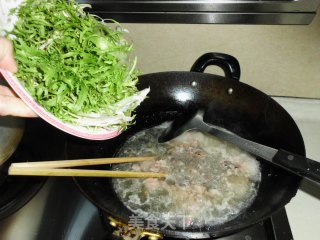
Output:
[[190, 52, 241, 81]]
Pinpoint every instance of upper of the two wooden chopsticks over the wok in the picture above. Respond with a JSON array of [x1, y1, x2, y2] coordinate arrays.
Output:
[[11, 157, 155, 168]]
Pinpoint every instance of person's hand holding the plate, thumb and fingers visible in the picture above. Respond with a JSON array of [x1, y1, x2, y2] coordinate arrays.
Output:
[[0, 37, 37, 117]]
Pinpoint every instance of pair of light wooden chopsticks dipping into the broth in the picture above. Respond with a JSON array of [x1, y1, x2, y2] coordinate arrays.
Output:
[[8, 157, 166, 178]]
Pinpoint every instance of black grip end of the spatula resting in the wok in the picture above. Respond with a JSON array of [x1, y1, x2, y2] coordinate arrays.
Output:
[[272, 150, 320, 185]]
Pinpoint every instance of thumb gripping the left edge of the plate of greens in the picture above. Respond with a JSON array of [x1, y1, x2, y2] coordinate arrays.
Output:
[[0, 37, 18, 73]]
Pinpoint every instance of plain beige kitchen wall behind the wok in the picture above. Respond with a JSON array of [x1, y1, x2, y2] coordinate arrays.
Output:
[[124, 14, 320, 98]]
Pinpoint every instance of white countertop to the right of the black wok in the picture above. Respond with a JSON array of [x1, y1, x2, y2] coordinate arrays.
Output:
[[274, 97, 320, 240]]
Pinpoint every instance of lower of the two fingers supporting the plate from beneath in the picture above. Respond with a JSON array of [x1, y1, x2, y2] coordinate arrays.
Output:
[[0, 95, 37, 117]]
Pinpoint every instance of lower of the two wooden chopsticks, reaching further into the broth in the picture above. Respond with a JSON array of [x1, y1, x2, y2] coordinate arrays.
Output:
[[8, 166, 167, 178]]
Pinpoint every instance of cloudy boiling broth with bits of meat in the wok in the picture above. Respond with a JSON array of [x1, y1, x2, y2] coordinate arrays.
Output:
[[113, 127, 261, 228]]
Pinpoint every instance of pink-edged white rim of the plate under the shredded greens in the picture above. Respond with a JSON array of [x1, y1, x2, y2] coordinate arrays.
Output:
[[0, 69, 121, 140]]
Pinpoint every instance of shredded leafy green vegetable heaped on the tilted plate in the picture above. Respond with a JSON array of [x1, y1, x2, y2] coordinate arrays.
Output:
[[9, 0, 145, 128]]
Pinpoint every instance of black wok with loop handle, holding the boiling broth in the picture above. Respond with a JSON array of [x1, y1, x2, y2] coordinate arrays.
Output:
[[67, 53, 305, 239]]
